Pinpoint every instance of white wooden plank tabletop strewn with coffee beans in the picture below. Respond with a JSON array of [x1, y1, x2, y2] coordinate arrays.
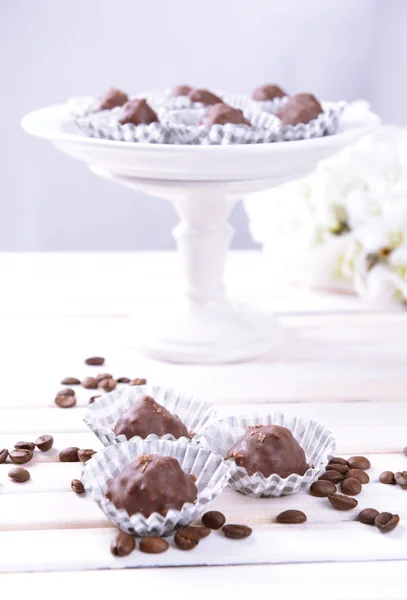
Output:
[[0, 252, 407, 600]]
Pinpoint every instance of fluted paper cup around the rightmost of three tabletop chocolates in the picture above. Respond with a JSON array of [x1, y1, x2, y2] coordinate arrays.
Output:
[[199, 413, 336, 498]]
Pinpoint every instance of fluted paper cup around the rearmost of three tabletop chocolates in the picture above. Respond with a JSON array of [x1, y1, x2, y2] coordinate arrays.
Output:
[[83, 385, 216, 446]]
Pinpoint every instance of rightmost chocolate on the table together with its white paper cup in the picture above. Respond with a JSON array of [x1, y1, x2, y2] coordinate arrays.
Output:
[[199, 413, 336, 497]]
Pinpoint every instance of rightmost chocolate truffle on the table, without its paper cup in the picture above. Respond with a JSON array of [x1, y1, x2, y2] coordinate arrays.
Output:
[[226, 425, 308, 477]]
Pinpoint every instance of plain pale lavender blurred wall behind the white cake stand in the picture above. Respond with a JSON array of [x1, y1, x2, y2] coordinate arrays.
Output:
[[0, 0, 407, 251]]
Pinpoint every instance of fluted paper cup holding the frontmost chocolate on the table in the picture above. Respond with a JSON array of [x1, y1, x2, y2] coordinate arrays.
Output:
[[82, 438, 230, 536]]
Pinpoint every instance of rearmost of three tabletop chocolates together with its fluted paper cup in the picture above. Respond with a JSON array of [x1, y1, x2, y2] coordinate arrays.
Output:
[[84, 385, 216, 446]]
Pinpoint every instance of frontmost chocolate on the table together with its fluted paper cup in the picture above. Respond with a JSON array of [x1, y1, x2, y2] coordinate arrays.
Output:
[[82, 438, 230, 537]]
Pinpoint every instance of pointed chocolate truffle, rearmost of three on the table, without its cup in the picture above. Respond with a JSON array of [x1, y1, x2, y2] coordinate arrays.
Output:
[[114, 396, 189, 440]]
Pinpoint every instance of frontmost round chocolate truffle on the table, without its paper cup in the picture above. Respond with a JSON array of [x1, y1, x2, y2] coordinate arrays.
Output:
[[106, 454, 198, 517]]
